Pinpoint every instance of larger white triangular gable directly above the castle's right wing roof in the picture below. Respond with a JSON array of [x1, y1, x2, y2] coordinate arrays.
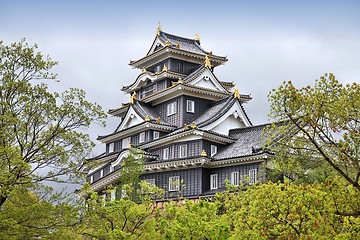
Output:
[[202, 101, 251, 135]]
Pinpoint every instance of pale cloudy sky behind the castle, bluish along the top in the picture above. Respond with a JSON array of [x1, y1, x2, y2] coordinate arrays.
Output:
[[0, 0, 360, 153]]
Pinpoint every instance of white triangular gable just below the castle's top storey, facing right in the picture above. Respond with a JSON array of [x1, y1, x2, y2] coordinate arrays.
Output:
[[188, 68, 228, 92]]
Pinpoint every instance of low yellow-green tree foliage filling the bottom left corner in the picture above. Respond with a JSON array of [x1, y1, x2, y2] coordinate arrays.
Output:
[[0, 187, 81, 240]]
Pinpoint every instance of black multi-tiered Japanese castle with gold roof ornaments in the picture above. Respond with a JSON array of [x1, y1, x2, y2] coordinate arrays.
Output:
[[82, 28, 270, 199]]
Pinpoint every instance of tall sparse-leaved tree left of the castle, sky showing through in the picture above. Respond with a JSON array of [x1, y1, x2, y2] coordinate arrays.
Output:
[[0, 40, 106, 207]]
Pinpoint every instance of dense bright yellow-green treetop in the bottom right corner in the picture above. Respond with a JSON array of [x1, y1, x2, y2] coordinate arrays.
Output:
[[217, 178, 360, 239]]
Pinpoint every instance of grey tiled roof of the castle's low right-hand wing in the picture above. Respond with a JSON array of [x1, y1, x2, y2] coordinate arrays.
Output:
[[214, 124, 268, 160]]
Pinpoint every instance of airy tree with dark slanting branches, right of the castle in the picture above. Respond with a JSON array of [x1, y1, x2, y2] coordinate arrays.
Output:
[[267, 73, 360, 195]]
